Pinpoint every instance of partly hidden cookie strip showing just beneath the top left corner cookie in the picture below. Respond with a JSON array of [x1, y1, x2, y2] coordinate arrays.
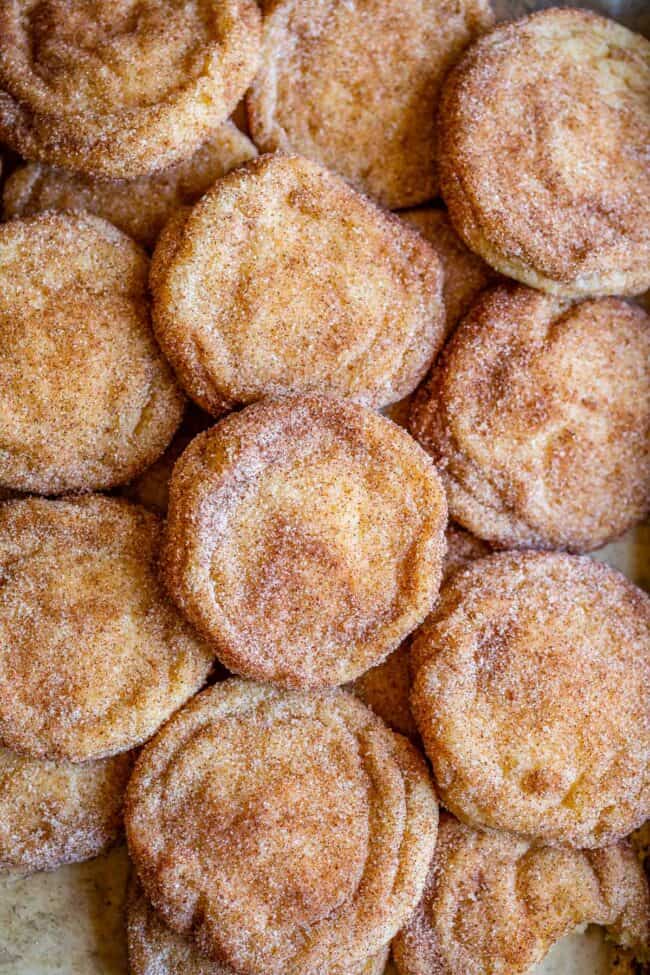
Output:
[[3, 122, 257, 247]]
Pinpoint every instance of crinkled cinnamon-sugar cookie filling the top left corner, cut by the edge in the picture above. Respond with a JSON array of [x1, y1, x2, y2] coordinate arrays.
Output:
[[0, 0, 261, 179]]
